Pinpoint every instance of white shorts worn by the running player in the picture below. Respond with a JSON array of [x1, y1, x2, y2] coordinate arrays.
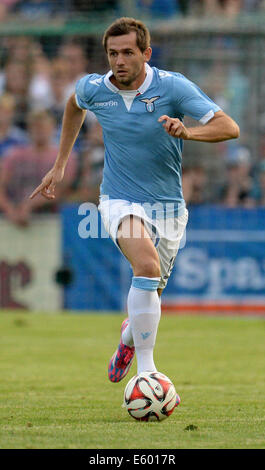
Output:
[[98, 199, 188, 289]]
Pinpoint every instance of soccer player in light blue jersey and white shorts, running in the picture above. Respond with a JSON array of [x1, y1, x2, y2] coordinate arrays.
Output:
[[30, 18, 239, 382]]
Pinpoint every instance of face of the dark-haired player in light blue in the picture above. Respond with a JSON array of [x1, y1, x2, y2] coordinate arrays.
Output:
[[107, 31, 152, 90]]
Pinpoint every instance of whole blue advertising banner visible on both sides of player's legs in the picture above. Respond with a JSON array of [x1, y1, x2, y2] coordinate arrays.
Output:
[[61, 205, 265, 311]]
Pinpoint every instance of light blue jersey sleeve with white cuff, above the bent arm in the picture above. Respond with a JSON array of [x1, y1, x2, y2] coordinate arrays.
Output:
[[172, 76, 221, 124]]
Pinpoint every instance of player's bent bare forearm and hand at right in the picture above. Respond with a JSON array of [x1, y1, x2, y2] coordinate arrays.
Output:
[[158, 111, 240, 142]]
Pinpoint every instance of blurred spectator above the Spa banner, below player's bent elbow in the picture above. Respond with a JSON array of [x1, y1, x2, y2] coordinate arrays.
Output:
[[214, 145, 253, 207]]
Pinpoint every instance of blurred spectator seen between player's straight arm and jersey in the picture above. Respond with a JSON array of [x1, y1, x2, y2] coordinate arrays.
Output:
[[68, 121, 105, 204]]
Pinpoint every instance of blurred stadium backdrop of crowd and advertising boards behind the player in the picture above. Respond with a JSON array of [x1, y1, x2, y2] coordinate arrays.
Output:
[[0, 0, 265, 315]]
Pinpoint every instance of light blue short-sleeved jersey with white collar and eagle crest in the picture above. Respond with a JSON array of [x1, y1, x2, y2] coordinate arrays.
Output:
[[76, 64, 220, 215]]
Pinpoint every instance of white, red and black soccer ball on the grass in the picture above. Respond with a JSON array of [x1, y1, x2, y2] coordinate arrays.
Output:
[[123, 372, 180, 421]]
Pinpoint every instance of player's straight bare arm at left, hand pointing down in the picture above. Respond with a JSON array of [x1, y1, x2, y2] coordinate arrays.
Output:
[[30, 94, 86, 199]]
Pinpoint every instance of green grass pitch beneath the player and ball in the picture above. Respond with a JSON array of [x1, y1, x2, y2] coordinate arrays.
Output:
[[0, 311, 265, 449]]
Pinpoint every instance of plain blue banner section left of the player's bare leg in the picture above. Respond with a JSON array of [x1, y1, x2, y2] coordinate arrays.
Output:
[[61, 205, 130, 311]]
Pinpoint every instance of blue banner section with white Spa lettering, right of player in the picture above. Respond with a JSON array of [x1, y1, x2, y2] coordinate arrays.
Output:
[[164, 207, 265, 306]]
